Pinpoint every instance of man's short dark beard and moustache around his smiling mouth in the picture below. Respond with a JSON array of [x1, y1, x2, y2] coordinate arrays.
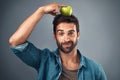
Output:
[[56, 39, 78, 54]]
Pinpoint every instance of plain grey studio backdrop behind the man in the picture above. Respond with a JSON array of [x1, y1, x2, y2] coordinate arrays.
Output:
[[0, 0, 120, 80]]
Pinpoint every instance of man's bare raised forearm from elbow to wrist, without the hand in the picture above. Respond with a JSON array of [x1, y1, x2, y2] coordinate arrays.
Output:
[[9, 7, 44, 46]]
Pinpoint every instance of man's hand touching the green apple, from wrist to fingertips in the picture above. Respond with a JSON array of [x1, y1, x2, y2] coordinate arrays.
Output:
[[41, 3, 66, 16]]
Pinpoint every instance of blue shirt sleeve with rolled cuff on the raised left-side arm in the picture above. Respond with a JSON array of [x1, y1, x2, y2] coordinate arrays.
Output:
[[11, 41, 42, 69]]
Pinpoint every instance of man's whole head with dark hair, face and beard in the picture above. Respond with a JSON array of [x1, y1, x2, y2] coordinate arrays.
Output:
[[53, 14, 80, 54]]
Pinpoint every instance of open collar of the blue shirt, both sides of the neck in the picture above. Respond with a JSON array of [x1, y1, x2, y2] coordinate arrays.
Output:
[[54, 48, 87, 69]]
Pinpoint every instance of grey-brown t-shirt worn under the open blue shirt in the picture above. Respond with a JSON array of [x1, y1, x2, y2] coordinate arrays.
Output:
[[59, 67, 78, 80]]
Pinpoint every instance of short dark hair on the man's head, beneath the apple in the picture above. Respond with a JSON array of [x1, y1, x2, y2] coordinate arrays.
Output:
[[53, 14, 79, 34]]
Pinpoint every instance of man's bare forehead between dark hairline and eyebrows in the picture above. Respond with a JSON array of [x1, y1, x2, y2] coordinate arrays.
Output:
[[56, 22, 76, 31]]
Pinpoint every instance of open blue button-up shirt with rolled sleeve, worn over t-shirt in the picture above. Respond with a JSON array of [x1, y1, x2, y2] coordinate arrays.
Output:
[[11, 41, 107, 80]]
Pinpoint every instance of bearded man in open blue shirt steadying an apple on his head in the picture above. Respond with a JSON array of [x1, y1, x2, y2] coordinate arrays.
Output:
[[9, 3, 107, 80]]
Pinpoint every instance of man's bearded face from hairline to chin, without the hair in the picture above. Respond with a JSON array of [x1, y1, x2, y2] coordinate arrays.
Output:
[[55, 22, 80, 54]]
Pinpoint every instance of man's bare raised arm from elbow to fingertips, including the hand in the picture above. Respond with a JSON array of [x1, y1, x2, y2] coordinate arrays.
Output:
[[9, 3, 63, 46]]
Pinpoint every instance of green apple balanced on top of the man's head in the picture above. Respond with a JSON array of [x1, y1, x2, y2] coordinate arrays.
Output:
[[60, 6, 72, 16]]
